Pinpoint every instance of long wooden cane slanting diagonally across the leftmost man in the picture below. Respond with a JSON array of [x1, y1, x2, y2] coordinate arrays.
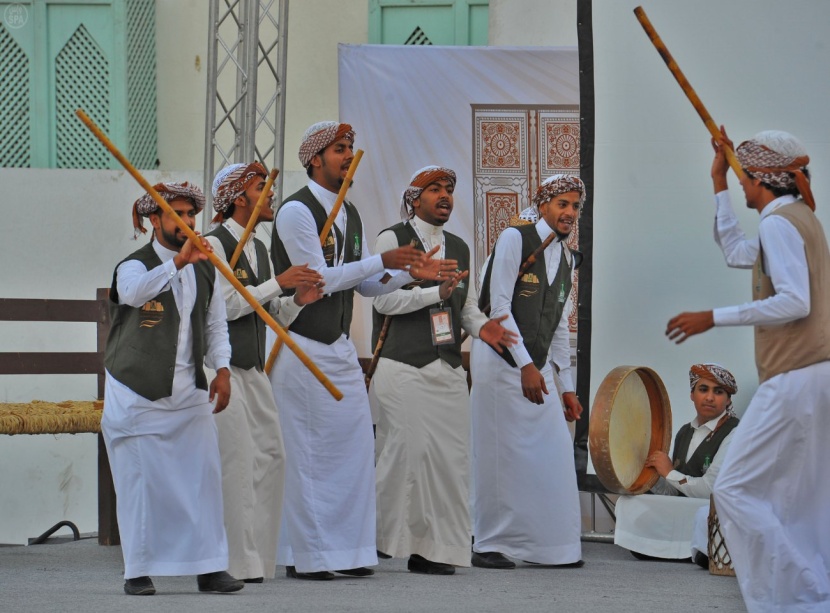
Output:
[[75, 109, 343, 400]]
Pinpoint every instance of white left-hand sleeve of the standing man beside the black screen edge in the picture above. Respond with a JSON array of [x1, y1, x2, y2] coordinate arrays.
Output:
[[490, 228, 533, 368]]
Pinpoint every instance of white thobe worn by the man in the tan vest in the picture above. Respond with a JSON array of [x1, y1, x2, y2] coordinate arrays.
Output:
[[714, 192, 830, 613]]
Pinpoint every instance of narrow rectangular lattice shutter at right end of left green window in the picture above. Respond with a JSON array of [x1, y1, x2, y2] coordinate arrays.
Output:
[[127, 0, 158, 168]]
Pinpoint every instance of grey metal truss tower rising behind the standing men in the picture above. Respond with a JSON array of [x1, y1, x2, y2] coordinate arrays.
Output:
[[202, 0, 288, 231]]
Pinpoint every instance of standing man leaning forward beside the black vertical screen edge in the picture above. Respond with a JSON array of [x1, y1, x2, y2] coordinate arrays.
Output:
[[471, 175, 585, 569]]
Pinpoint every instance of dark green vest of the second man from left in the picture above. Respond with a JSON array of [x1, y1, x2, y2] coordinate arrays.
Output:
[[208, 226, 271, 371]]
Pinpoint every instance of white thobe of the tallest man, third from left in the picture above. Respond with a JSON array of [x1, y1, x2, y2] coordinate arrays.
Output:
[[270, 181, 413, 573]]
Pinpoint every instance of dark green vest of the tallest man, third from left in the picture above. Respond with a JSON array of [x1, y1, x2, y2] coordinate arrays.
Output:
[[271, 187, 363, 345]]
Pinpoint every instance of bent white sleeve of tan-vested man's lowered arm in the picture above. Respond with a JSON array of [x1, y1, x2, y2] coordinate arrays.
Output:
[[713, 215, 810, 326]]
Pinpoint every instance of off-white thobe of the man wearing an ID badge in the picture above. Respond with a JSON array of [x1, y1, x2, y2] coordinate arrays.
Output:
[[369, 217, 487, 566]]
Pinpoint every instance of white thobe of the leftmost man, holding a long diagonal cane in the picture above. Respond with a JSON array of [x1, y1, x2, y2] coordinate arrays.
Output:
[[101, 241, 230, 579]]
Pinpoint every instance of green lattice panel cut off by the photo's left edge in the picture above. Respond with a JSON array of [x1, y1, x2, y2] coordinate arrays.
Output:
[[0, 24, 31, 168]]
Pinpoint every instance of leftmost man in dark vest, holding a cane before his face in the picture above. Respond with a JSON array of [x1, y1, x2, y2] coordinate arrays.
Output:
[[101, 182, 244, 595]]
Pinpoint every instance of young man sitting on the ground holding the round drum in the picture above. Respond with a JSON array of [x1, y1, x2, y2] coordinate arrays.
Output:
[[614, 364, 738, 568]]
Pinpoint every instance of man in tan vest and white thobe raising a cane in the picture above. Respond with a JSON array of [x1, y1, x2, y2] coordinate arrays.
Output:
[[666, 130, 830, 613]]
